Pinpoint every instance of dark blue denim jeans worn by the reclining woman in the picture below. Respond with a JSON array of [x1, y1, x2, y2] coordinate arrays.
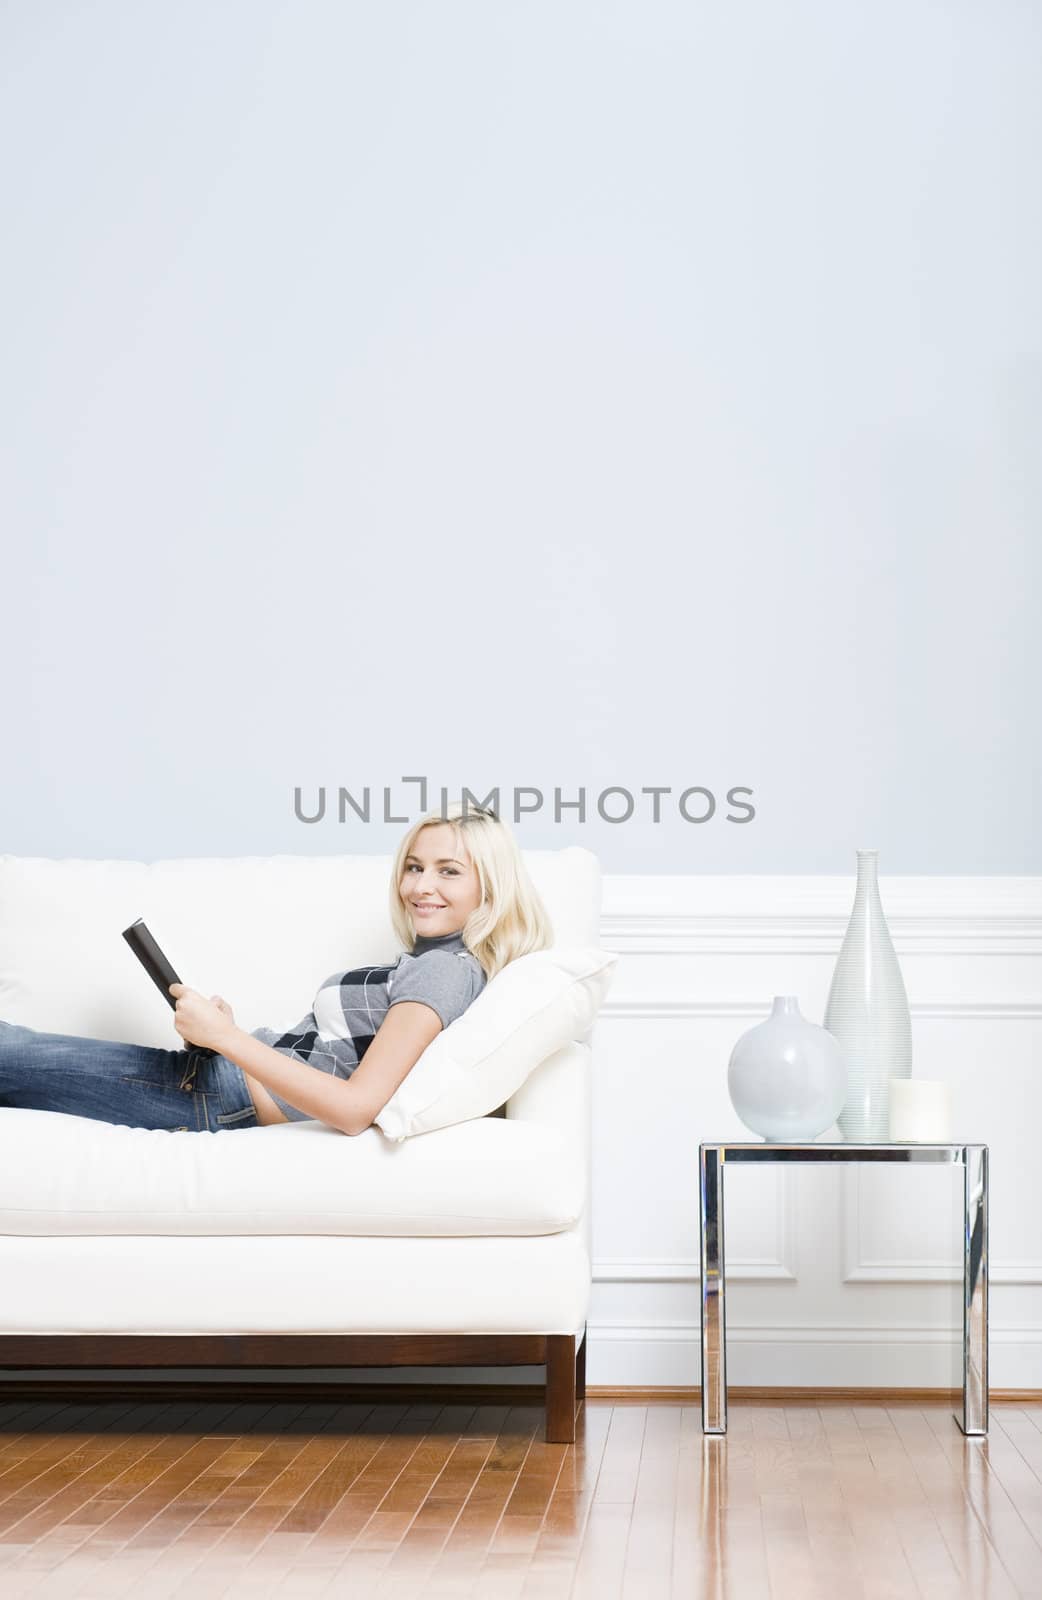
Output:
[[0, 1022, 258, 1133]]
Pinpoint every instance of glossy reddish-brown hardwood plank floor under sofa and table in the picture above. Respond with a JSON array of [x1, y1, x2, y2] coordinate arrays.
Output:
[[0, 1398, 1042, 1600]]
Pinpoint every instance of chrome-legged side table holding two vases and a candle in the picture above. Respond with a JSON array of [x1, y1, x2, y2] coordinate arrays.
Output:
[[698, 1141, 988, 1437]]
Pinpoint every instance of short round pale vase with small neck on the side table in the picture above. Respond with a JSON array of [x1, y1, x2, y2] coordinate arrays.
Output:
[[727, 995, 847, 1144]]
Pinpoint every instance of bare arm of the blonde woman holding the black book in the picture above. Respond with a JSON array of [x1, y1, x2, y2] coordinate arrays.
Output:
[[170, 984, 442, 1134]]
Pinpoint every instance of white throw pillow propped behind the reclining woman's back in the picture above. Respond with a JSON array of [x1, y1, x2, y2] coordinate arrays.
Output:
[[376, 947, 618, 1142]]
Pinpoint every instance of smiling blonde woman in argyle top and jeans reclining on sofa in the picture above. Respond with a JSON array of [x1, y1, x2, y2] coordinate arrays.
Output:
[[0, 806, 552, 1134]]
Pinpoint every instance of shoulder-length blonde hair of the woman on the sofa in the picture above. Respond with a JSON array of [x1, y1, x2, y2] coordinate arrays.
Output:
[[391, 803, 554, 978]]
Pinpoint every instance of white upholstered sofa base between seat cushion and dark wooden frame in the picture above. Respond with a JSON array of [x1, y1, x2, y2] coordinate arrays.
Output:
[[0, 1232, 591, 1331]]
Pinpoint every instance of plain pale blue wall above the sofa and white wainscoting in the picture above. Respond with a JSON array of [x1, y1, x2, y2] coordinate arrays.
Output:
[[0, 0, 1042, 874]]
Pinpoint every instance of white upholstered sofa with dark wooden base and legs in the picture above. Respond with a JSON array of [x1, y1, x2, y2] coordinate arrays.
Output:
[[0, 848, 600, 1440]]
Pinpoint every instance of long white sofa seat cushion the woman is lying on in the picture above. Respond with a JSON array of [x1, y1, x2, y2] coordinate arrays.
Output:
[[0, 1109, 584, 1237]]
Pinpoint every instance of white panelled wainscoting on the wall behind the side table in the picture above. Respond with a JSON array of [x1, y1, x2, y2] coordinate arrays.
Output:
[[587, 872, 1042, 1389]]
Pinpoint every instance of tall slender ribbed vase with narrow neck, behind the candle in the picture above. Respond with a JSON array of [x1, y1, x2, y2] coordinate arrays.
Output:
[[824, 850, 912, 1142]]
